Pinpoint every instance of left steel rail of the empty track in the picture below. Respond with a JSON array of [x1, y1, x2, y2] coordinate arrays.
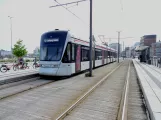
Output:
[[55, 62, 123, 120]]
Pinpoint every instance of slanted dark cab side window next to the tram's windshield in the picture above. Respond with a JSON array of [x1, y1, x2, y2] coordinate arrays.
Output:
[[62, 43, 71, 63]]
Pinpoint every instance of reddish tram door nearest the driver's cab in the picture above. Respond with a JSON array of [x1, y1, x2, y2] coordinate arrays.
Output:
[[75, 45, 81, 72]]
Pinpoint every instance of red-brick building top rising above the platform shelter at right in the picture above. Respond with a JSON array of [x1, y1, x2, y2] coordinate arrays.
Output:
[[140, 35, 157, 47]]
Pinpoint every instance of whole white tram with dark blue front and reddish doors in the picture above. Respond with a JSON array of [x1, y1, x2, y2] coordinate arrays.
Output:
[[39, 30, 117, 76]]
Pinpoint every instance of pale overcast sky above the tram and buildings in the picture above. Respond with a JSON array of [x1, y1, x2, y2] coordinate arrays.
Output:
[[0, 0, 161, 53]]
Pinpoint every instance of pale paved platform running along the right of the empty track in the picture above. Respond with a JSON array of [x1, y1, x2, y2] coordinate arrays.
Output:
[[133, 59, 161, 120]]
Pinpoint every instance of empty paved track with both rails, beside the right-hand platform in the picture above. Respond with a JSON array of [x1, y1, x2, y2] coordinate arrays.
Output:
[[53, 61, 148, 120]]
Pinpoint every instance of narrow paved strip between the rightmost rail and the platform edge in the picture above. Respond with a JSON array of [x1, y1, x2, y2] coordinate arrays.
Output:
[[127, 65, 150, 120]]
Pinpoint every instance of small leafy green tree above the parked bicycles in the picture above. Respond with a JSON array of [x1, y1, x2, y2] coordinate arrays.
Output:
[[12, 40, 27, 57]]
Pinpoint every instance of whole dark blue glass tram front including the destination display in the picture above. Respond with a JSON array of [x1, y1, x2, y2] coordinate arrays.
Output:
[[40, 31, 67, 61]]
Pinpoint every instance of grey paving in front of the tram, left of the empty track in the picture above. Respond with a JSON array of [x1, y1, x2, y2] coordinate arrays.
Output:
[[0, 63, 122, 120]]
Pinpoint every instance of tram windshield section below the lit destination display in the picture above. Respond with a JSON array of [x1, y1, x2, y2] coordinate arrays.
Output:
[[40, 46, 63, 61]]
